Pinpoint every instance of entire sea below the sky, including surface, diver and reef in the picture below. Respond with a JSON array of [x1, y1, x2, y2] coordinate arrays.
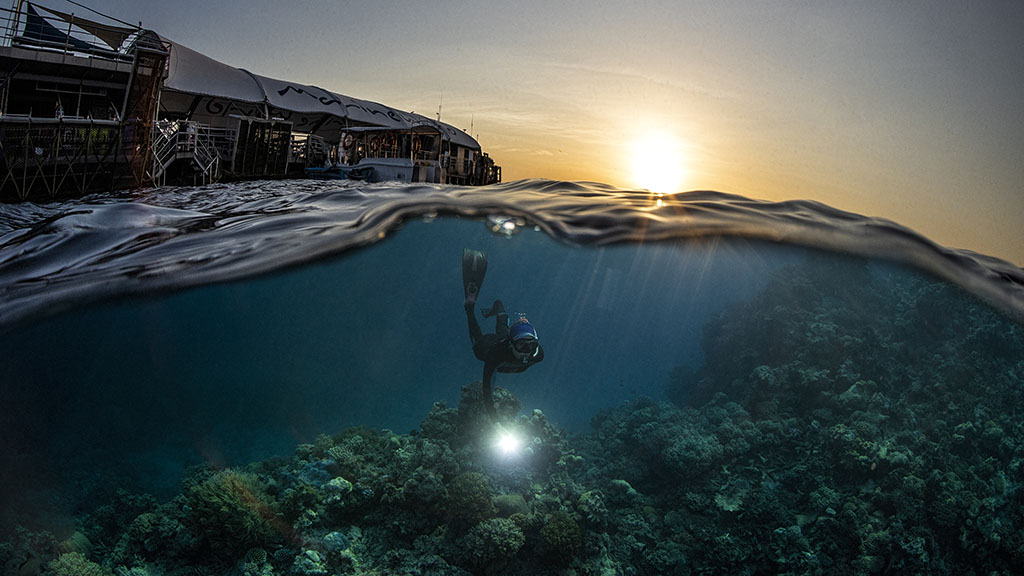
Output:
[[0, 180, 1024, 576]]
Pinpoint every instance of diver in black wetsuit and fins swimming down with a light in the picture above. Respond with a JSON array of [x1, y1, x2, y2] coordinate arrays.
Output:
[[462, 248, 544, 416]]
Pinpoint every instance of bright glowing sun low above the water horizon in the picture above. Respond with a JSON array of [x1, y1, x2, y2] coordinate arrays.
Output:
[[630, 129, 686, 194]]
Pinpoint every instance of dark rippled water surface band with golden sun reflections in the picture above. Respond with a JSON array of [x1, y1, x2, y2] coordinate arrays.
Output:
[[0, 180, 1024, 320]]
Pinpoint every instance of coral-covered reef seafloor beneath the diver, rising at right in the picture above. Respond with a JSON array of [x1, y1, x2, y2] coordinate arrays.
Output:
[[0, 256, 1024, 576]]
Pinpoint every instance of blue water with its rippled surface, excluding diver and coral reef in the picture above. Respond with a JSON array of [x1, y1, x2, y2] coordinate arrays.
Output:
[[0, 180, 1024, 569]]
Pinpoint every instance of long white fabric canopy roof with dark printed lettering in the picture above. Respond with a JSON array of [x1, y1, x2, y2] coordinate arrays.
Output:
[[164, 38, 480, 150]]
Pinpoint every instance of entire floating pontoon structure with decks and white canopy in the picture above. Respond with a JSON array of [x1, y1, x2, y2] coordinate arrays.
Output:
[[0, 0, 501, 199]]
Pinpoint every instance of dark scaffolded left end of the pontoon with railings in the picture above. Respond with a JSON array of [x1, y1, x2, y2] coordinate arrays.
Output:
[[0, 0, 170, 201]]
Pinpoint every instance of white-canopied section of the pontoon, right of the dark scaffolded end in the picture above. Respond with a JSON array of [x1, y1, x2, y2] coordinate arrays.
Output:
[[160, 38, 501, 184]]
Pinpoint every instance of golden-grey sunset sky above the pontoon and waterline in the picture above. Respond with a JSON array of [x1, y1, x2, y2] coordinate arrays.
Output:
[[61, 0, 1024, 265]]
